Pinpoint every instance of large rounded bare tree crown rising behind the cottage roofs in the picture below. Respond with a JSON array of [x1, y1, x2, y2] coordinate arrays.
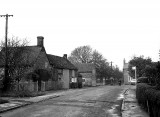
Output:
[[68, 45, 92, 63]]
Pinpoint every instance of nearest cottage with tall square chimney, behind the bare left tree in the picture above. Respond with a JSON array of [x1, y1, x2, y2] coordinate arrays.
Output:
[[0, 36, 51, 91]]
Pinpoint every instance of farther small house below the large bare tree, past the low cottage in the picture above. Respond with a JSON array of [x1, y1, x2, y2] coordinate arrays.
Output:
[[74, 63, 96, 86]]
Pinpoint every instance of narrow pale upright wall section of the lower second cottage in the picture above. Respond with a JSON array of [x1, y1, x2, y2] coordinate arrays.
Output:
[[62, 69, 70, 89]]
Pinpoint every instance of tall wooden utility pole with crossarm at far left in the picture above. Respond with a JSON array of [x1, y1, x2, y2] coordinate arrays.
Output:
[[0, 14, 13, 90]]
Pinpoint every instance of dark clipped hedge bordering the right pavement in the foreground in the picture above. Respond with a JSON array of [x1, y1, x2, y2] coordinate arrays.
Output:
[[136, 83, 160, 117]]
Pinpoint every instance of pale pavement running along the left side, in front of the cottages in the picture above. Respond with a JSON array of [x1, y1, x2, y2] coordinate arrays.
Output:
[[0, 89, 81, 113]]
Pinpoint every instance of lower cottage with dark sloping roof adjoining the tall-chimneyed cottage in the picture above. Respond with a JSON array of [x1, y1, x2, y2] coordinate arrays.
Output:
[[47, 54, 77, 89]]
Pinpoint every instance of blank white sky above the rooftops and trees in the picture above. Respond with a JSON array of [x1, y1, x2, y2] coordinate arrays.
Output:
[[0, 0, 160, 70]]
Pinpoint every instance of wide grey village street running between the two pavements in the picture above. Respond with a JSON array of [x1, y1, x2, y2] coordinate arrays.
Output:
[[1, 86, 126, 117]]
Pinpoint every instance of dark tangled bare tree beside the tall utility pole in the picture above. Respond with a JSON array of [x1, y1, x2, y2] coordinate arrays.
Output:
[[0, 37, 28, 91]]
